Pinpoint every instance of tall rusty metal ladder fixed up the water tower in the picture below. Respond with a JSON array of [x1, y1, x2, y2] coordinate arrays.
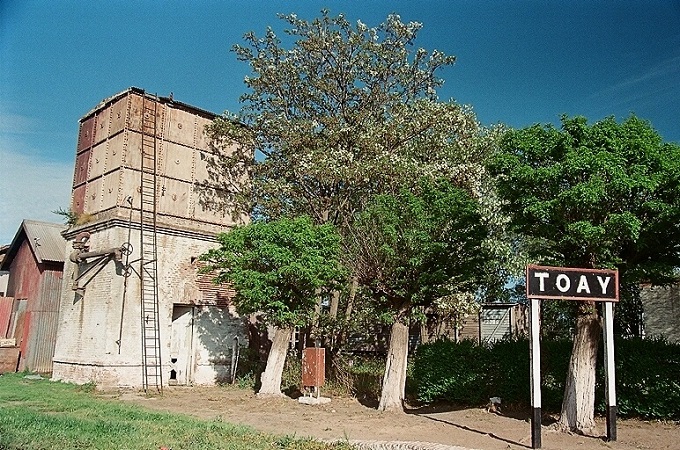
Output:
[[139, 93, 163, 392]]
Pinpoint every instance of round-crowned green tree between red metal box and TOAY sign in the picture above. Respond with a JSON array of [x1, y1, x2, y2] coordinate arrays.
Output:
[[346, 180, 487, 410]]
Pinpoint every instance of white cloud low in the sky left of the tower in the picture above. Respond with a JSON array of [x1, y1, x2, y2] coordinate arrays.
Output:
[[0, 144, 73, 245]]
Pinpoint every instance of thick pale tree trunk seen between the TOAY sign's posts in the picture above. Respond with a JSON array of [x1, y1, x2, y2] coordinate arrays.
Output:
[[557, 302, 602, 434]]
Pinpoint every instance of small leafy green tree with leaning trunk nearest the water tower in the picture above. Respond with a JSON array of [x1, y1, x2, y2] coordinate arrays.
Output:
[[201, 217, 344, 395]]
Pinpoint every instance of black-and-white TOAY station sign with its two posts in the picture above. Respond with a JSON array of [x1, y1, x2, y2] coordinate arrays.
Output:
[[526, 265, 619, 448]]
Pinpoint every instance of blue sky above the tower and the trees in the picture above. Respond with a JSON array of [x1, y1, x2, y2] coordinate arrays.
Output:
[[0, 0, 680, 244]]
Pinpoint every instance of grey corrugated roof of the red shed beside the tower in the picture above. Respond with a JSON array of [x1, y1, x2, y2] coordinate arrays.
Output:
[[0, 220, 67, 270]]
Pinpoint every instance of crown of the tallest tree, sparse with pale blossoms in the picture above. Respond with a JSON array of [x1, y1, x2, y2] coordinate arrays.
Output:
[[207, 11, 488, 228]]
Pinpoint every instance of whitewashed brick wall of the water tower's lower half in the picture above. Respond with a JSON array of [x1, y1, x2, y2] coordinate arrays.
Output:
[[53, 226, 247, 386]]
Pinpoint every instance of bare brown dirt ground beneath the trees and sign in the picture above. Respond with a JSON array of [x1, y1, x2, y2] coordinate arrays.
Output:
[[114, 387, 680, 450]]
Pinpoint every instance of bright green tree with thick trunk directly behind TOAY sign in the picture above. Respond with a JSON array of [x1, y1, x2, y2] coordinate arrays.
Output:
[[489, 116, 680, 432]]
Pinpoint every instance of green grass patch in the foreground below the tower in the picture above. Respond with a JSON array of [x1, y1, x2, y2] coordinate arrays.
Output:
[[0, 374, 352, 450]]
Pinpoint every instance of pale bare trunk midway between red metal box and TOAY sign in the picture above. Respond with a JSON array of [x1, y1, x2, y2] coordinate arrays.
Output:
[[378, 320, 408, 411]]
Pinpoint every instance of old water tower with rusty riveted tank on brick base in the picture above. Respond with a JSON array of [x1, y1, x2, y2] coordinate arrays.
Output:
[[53, 88, 247, 390]]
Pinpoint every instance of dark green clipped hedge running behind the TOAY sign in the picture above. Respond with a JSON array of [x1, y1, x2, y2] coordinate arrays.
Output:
[[409, 338, 680, 420]]
